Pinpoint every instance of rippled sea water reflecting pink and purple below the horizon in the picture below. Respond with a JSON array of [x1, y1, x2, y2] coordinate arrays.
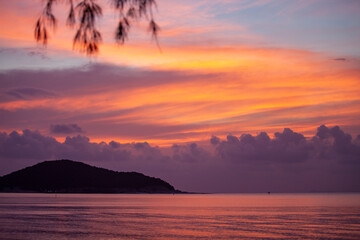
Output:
[[0, 193, 360, 240]]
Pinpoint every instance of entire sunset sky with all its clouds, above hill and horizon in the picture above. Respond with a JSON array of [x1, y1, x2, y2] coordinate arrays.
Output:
[[0, 0, 360, 192]]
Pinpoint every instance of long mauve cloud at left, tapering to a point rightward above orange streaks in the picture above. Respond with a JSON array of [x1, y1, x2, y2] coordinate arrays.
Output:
[[0, 63, 211, 97]]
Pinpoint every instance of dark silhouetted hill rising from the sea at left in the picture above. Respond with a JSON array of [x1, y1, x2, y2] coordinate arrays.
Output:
[[0, 160, 180, 193]]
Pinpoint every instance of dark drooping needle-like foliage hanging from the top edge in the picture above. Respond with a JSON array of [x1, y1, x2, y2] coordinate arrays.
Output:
[[34, 0, 159, 55]]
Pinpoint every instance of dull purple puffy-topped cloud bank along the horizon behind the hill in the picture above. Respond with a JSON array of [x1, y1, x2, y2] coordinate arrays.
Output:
[[0, 125, 360, 192]]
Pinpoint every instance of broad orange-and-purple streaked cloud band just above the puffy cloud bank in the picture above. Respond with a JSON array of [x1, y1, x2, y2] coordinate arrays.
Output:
[[0, 59, 360, 146]]
